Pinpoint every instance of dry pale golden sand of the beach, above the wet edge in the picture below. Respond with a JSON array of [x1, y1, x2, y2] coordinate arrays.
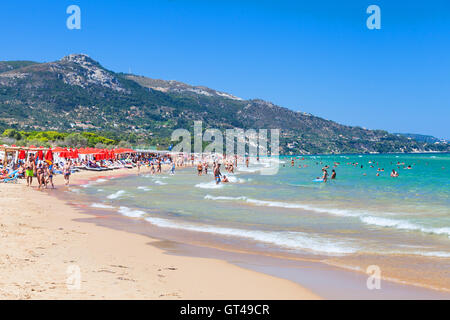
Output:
[[0, 169, 319, 299]]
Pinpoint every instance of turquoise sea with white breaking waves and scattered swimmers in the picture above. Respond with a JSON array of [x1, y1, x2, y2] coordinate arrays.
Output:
[[72, 154, 450, 289]]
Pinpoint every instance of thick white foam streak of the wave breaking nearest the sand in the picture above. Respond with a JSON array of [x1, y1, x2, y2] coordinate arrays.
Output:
[[145, 217, 357, 254]]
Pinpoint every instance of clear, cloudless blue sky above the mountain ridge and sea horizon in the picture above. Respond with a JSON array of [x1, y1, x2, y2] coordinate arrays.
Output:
[[0, 0, 450, 139]]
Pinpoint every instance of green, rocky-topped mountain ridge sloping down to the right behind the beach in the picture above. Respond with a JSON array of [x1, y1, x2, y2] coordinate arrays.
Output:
[[0, 54, 449, 154]]
